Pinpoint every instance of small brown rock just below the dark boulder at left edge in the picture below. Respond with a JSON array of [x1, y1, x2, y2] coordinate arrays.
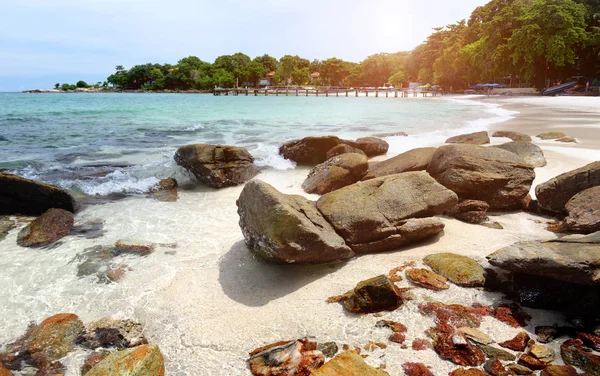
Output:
[[17, 208, 74, 247]]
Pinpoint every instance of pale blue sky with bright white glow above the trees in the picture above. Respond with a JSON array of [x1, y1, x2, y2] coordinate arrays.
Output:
[[0, 0, 487, 92]]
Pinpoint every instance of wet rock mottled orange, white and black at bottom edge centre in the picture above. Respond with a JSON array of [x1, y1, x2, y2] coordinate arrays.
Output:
[[248, 339, 325, 376]]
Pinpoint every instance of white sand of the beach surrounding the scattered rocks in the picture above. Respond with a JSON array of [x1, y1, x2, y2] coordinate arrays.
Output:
[[0, 97, 600, 376]]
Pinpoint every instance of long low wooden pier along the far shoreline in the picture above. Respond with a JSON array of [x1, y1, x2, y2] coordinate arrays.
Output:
[[213, 87, 442, 98]]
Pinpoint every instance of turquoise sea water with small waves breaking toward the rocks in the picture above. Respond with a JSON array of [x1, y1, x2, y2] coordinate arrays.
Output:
[[0, 93, 506, 195]]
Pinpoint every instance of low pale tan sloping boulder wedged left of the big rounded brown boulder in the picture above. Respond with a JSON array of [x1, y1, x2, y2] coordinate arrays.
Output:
[[363, 148, 437, 180]]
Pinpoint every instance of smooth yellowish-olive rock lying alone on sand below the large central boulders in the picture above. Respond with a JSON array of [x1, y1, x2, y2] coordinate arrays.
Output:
[[423, 253, 485, 287]]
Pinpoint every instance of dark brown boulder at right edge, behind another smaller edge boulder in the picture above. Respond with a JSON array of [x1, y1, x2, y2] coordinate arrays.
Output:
[[535, 161, 600, 212]]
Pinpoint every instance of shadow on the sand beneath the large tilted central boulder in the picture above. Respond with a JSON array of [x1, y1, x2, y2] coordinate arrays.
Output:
[[219, 240, 344, 307]]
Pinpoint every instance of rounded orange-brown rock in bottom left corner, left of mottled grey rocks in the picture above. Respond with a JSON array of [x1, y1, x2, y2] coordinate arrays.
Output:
[[23, 313, 84, 368]]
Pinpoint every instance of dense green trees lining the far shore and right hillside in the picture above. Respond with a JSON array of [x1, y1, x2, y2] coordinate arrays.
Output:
[[96, 0, 600, 90]]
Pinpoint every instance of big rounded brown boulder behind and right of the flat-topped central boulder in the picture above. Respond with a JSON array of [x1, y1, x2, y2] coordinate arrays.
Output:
[[427, 145, 535, 209]]
